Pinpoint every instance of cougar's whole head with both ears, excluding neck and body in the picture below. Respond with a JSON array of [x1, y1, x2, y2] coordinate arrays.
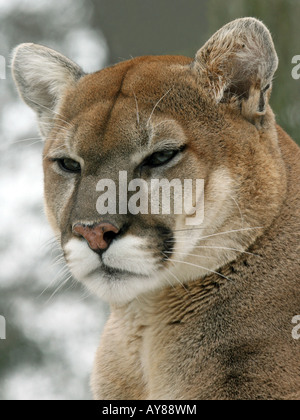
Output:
[[13, 19, 285, 303]]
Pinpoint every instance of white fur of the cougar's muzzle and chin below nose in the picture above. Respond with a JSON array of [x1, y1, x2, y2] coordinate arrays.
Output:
[[64, 235, 162, 303]]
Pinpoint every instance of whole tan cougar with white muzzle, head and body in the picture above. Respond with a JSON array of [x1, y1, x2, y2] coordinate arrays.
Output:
[[12, 18, 300, 400]]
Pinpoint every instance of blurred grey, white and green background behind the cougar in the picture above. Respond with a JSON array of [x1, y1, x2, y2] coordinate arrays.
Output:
[[0, 0, 300, 400]]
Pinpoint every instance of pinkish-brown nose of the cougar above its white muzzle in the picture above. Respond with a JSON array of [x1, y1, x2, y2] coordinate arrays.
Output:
[[73, 223, 119, 252]]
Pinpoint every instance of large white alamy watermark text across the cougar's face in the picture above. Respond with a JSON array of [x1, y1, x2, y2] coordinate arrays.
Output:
[[96, 171, 204, 226]]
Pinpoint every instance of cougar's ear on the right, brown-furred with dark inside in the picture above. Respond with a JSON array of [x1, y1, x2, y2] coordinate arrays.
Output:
[[194, 18, 278, 123]]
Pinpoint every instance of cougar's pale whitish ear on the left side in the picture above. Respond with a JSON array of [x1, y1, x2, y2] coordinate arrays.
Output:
[[12, 44, 84, 137]]
